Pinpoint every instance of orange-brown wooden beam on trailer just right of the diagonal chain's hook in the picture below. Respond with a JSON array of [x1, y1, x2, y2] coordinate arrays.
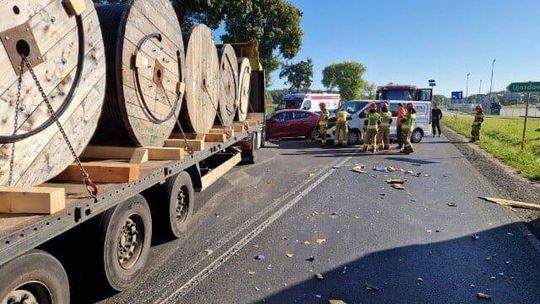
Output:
[[54, 162, 141, 183]]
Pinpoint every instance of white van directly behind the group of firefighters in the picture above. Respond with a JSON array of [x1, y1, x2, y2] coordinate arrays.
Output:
[[327, 100, 432, 145]]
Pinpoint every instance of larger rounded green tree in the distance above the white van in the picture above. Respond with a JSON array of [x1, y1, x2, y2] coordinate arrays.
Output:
[[322, 61, 369, 100]]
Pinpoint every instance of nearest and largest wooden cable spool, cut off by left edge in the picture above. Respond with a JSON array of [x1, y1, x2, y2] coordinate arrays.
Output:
[[0, 0, 105, 187]]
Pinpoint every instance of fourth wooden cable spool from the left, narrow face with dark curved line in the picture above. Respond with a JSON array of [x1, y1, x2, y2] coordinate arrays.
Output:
[[218, 44, 239, 127]]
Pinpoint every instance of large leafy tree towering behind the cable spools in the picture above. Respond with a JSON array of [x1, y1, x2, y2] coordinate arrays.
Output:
[[94, 0, 304, 82]]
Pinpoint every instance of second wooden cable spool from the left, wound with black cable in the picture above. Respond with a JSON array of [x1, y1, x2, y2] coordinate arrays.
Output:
[[92, 0, 185, 146]]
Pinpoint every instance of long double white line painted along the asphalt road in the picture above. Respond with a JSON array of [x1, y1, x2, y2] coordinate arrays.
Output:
[[154, 157, 352, 303]]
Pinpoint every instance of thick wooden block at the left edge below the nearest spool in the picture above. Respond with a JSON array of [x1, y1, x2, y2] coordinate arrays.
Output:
[[0, 187, 66, 214]]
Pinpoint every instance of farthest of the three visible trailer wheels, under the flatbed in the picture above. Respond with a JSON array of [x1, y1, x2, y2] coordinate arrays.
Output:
[[149, 171, 195, 239]]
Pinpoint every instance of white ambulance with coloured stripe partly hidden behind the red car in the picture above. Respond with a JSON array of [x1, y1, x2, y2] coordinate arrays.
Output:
[[276, 93, 341, 113]]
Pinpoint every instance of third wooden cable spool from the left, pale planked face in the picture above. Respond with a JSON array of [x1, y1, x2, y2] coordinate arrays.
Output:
[[182, 24, 221, 134]]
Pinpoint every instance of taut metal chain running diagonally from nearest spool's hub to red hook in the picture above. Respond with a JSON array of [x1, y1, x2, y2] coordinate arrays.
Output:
[[22, 57, 98, 198]]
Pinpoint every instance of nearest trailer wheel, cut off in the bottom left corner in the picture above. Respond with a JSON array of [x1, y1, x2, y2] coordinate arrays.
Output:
[[0, 250, 70, 304]]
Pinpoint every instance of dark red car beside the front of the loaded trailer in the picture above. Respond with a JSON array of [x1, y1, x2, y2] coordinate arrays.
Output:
[[266, 110, 319, 139]]
